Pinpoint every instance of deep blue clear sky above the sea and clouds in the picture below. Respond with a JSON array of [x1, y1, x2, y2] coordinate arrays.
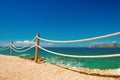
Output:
[[0, 0, 120, 46]]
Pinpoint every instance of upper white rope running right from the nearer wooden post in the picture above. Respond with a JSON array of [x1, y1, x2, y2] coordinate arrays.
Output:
[[37, 32, 120, 43]]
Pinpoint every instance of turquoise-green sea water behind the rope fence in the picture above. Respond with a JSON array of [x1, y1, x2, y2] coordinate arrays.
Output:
[[0, 48, 120, 69]]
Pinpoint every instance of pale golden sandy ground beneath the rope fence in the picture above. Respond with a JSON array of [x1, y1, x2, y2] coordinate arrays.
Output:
[[0, 55, 120, 80]]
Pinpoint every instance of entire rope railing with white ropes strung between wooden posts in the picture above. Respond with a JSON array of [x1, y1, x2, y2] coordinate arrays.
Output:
[[0, 32, 120, 62]]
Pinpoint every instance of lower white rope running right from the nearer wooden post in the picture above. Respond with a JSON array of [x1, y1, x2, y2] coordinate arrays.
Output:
[[38, 46, 120, 58]]
